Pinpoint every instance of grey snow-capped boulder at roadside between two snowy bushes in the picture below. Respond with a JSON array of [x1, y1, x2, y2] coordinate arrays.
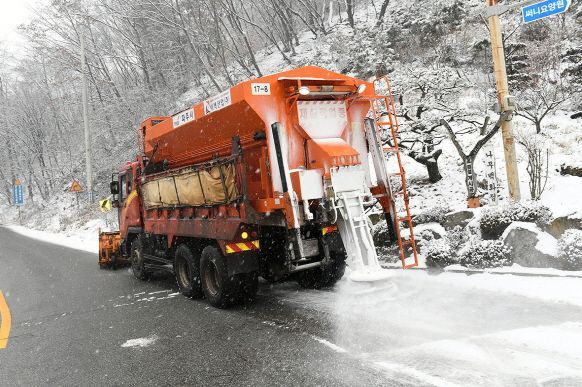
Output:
[[501, 222, 562, 269]]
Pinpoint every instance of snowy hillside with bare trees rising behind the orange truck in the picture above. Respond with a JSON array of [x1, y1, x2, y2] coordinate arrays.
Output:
[[0, 0, 582, 241]]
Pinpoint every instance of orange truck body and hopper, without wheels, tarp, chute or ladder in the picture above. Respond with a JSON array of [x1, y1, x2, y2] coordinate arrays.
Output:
[[101, 66, 402, 290]]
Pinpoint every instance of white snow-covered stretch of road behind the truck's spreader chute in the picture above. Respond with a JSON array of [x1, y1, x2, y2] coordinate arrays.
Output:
[[274, 271, 582, 386]]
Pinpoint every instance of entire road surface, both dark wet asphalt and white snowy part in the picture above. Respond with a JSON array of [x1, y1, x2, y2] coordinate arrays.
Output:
[[0, 228, 582, 386]]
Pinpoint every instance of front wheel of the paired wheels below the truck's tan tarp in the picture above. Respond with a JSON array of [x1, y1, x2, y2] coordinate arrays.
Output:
[[174, 244, 204, 298]]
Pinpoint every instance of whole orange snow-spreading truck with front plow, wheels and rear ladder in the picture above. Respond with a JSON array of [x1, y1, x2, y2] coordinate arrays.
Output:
[[99, 66, 418, 307]]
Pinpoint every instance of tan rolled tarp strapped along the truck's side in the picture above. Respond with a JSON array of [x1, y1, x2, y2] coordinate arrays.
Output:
[[142, 163, 238, 209]]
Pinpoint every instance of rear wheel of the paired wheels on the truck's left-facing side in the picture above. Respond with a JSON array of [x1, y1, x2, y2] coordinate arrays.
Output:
[[200, 246, 238, 308]]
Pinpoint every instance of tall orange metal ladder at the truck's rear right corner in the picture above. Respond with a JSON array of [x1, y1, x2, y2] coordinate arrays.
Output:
[[370, 76, 418, 269]]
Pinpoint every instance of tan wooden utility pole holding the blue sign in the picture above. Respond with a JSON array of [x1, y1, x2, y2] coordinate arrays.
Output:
[[485, 0, 521, 201]]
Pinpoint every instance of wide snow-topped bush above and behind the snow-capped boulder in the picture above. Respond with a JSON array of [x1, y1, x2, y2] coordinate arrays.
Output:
[[480, 202, 552, 239]]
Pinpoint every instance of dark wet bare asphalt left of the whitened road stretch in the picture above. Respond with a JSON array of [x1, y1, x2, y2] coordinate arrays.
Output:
[[0, 228, 396, 386]]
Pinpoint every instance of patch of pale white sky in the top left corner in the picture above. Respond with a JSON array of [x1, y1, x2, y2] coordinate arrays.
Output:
[[0, 0, 41, 50]]
